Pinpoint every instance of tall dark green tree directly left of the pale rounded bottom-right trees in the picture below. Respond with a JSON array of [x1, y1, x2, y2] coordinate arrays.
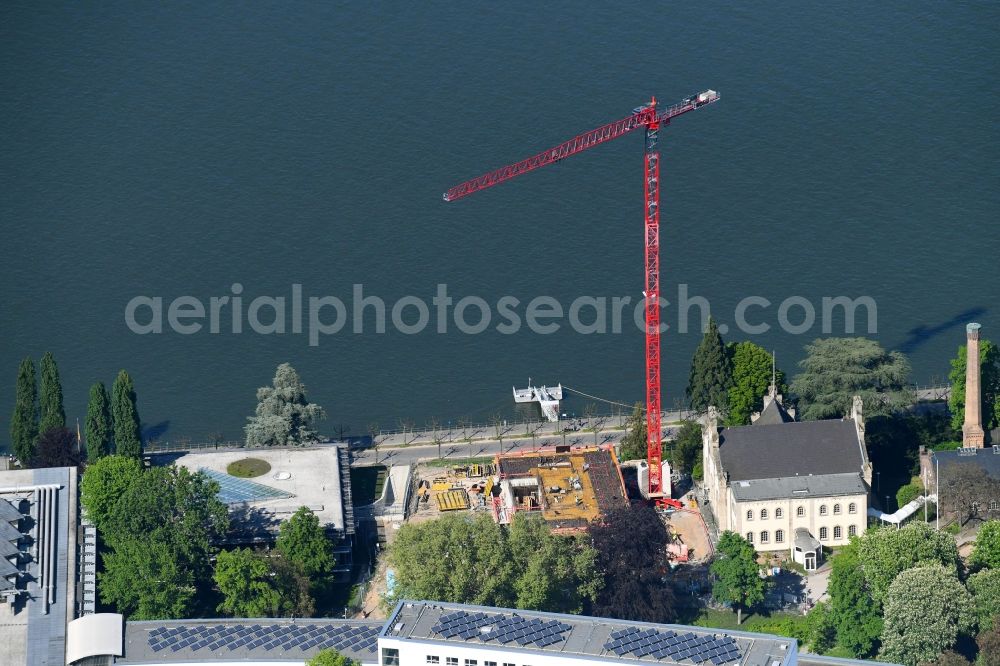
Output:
[[827, 540, 882, 657]]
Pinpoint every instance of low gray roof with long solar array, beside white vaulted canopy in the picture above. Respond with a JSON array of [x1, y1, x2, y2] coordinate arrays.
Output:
[[115, 618, 382, 664]]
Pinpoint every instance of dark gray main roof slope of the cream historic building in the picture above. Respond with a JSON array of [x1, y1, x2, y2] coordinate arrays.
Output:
[[719, 420, 864, 485]]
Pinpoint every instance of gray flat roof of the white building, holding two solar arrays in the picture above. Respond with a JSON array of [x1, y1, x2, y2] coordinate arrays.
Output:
[[381, 601, 795, 666]]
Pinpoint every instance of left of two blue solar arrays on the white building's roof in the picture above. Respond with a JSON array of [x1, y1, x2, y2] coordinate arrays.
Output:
[[431, 611, 573, 647]]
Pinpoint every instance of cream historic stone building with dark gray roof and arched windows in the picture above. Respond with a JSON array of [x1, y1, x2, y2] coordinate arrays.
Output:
[[702, 387, 872, 569]]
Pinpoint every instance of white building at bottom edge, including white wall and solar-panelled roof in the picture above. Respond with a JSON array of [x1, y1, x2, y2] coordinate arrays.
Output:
[[379, 602, 798, 666]]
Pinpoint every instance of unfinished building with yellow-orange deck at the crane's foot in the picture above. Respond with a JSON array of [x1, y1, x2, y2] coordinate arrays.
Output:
[[491, 446, 628, 532]]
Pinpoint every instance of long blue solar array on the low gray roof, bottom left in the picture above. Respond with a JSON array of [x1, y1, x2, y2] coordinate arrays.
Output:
[[147, 624, 382, 654]]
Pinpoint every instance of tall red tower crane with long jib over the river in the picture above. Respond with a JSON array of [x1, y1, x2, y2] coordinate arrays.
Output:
[[444, 90, 719, 497]]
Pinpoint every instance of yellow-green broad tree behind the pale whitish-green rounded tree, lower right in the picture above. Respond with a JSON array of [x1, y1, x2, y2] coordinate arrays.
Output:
[[857, 522, 958, 607]]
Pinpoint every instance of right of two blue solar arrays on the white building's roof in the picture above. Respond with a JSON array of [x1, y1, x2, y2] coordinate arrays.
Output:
[[604, 627, 742, 666]]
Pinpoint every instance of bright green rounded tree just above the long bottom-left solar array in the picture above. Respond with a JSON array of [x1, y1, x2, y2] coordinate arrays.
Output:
[[214, 548, 281, 617]]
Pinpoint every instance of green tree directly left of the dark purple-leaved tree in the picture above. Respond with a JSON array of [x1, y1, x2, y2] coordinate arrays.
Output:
[[508, 516, 602, 614]]
